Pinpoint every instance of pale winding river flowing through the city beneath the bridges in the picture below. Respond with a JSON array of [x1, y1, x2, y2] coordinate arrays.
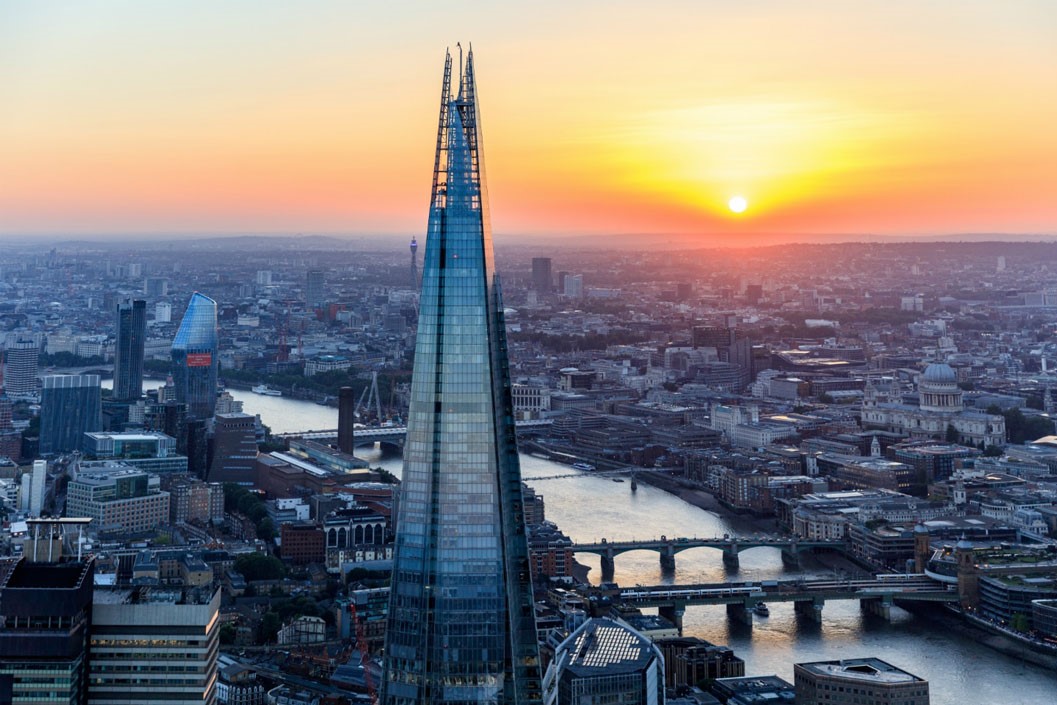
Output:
[[125, 382, 1057, 705]]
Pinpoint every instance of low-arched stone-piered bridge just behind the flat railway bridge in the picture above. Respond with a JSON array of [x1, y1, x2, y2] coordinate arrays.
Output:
[[571, 534, 847, 579]]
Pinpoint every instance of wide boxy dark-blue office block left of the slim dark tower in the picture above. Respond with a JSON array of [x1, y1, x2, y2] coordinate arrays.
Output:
[[40, 374, 103, 456]]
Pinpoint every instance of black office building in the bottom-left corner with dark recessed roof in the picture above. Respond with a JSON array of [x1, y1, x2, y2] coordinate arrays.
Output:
[[0, 549, 94, 705]]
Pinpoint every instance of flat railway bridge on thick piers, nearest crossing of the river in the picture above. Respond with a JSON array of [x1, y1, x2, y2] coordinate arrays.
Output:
[[604, 573, 959, 631]]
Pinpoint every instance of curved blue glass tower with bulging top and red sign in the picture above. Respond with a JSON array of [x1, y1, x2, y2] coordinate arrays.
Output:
[[172, 292, 218, 419]]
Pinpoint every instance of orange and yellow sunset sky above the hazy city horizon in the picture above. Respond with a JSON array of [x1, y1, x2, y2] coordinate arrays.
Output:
[[0, 0, 1057, 244]]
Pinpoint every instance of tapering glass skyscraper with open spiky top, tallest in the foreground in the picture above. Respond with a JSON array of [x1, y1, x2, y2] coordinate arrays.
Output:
[[382, 51, 541, 705]]
